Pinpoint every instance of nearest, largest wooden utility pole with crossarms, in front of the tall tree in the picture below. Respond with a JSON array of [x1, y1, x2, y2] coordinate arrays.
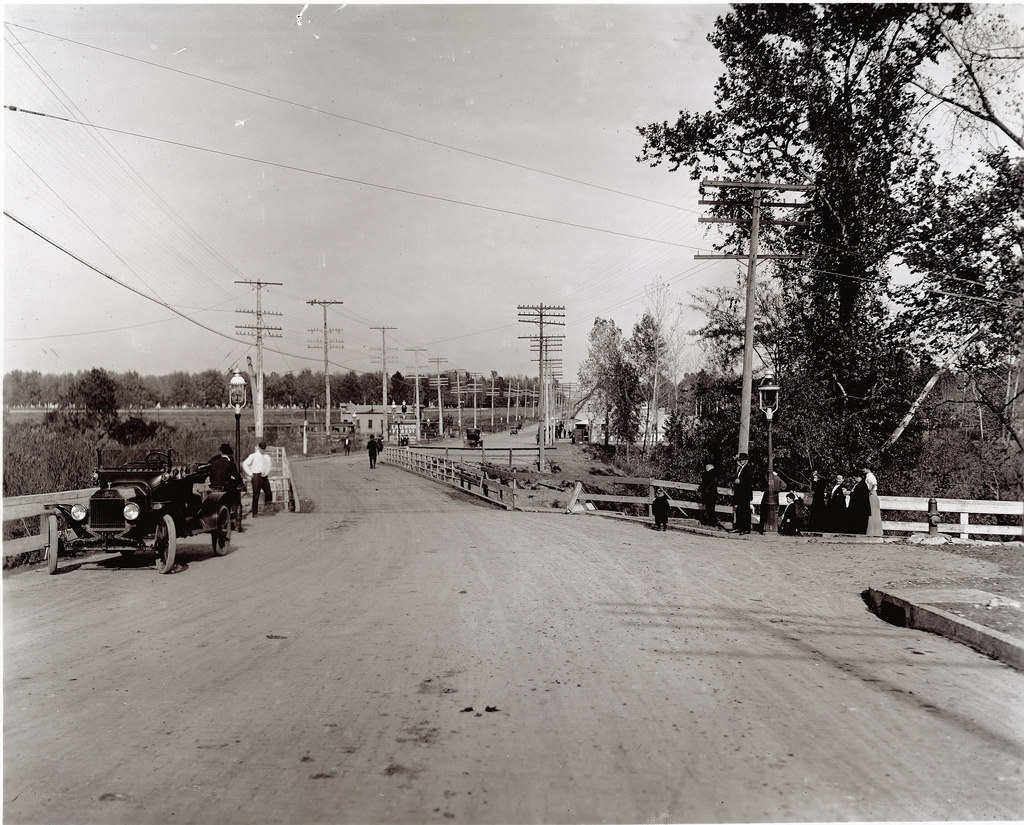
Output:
[[693, 175, 814, 452]]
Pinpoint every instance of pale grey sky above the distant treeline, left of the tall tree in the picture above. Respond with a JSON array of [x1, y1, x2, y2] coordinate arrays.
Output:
[[3, 3, 737, 382]]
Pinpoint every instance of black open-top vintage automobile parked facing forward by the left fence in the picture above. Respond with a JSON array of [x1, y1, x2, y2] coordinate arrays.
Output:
[[46, 449, 239, 574]]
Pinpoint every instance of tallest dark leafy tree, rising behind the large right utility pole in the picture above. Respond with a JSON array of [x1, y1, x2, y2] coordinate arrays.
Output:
[[638, 3, 968, 394]]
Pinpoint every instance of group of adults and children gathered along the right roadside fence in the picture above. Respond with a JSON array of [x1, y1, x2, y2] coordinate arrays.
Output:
[[651, 452, 882, 536]]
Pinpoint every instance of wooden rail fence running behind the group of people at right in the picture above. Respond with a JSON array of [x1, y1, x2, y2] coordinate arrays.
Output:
[[567, 476, 1024, 539]]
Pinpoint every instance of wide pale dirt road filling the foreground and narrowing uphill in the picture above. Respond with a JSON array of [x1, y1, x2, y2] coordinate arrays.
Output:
[[3, 455, 1024, 825]]
